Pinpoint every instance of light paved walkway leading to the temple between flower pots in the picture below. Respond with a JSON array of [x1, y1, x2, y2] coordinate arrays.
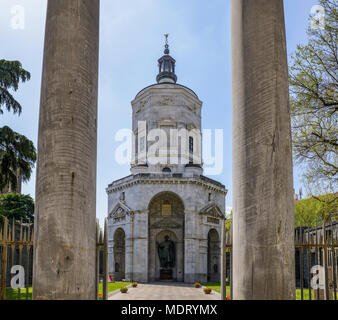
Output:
[[109, 282, 221, 300]]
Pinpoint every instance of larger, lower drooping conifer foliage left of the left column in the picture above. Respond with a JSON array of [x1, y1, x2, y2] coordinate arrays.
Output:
[[0, 126, 36, 192]]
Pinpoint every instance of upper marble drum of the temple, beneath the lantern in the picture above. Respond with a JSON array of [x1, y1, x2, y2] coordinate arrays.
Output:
[[131, 83, 202, 174]]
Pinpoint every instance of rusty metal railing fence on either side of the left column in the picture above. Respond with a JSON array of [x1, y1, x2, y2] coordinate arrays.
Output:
[[0, 218, 108, 300]]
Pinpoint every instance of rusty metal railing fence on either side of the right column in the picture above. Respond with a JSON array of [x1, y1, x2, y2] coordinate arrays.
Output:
[[224, 222, 338, 300]]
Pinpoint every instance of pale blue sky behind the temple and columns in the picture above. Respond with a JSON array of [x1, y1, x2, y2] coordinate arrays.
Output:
[[0, 0, 318, 224]]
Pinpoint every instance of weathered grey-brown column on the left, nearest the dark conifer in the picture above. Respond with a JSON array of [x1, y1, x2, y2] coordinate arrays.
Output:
[[33, 0, 99, 300]]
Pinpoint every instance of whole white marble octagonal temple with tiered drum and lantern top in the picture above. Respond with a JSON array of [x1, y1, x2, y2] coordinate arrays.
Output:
[[106, 41, 227, 283]]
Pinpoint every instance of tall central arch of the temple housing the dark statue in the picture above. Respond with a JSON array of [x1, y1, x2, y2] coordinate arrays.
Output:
[[148, 192, 184, 281]]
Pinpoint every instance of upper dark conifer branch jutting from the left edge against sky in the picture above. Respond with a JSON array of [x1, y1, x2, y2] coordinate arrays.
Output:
[[0, 60, 31, 114]]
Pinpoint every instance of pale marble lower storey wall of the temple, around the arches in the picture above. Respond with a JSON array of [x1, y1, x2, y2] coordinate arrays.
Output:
[[107, 175, 226, 282]]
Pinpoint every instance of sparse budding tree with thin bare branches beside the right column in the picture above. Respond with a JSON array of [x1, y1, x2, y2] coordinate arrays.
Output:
[[289, 0, 338, 194]]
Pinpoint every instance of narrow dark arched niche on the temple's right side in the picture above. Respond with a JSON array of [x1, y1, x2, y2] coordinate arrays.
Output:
[[207, 229, 220, 282]]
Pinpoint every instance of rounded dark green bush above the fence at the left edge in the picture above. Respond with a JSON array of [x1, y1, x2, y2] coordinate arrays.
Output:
[[0, 193, 34, 223]]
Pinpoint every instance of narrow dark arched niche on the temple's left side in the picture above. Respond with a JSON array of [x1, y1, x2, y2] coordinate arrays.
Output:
[[113, 228, 126, 281]]
